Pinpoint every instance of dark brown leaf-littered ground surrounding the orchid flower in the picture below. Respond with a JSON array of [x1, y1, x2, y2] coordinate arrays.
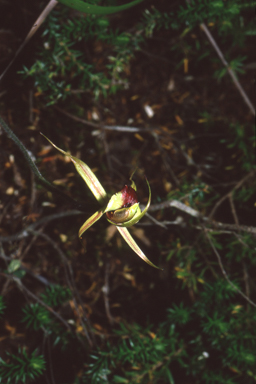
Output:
[[0, 3, 255, 382]]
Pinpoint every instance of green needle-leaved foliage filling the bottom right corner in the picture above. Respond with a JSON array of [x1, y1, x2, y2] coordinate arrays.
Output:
[[83, 279, 256, 383]]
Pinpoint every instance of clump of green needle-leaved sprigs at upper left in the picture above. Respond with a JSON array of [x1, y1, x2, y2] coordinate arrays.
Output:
[[22, 10, 142, 105]]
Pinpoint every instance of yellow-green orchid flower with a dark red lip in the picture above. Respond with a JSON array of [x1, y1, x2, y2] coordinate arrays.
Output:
[[42, 134, 161, 269]]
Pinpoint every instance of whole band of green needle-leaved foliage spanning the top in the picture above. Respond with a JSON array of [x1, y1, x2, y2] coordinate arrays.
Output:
[[21, 0, 255, 105]]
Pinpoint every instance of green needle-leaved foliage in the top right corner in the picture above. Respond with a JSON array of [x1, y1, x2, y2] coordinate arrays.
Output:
[[140, 0, 255, 85]]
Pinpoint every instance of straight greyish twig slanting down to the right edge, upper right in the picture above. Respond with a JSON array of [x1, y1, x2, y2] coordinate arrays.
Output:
[[200, 23, 255, 116]]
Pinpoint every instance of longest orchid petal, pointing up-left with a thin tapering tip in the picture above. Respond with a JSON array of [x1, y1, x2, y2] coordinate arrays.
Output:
[[41, 134, 107, 204]]
